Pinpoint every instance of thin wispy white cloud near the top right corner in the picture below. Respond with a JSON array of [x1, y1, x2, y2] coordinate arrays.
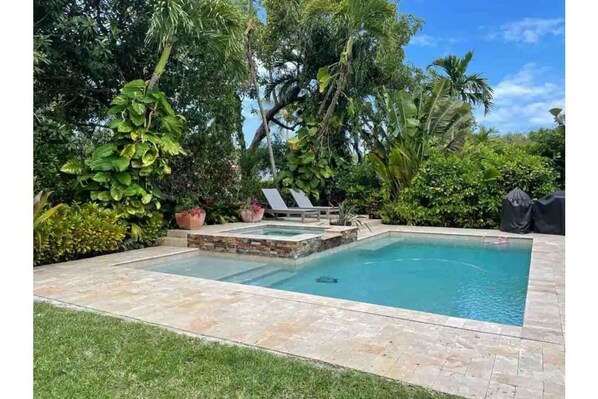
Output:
[[487, 18, 565, 43]]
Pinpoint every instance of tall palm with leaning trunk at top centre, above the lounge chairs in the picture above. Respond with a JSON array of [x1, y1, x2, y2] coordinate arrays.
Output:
[[303, 0, 404, 137]]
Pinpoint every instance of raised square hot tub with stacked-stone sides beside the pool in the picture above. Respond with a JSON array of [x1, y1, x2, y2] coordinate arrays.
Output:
[[187, 224, 358, 259]]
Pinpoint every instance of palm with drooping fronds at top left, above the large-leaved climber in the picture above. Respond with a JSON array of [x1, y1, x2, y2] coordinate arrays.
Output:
[[146, 0, 244, 89]]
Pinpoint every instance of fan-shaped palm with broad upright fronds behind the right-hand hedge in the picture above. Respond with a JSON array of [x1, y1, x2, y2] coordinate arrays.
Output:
[[366, 79, 473, 200]]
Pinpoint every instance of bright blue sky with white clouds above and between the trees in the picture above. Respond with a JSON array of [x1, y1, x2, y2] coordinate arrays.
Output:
[[244, 0, 565, 143]]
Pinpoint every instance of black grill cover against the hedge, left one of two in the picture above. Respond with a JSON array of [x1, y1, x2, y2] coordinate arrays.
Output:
[[500, 188, 533, 234]]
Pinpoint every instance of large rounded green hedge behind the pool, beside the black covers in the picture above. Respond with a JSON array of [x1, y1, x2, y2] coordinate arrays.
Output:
[[381, 145, 556, 228]]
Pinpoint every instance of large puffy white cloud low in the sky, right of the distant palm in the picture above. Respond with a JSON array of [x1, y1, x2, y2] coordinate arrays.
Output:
[[476, 63, 565, 133]]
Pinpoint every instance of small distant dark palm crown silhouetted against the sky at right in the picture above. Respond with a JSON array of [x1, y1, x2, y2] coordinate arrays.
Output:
[[429, 51, 494, 114]]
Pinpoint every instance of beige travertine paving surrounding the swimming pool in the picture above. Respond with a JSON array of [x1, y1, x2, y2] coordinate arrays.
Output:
[[34, 222, 565, 399]]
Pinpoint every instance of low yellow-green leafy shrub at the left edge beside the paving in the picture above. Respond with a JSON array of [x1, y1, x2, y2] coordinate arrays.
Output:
[[33, 202, 127, 265]]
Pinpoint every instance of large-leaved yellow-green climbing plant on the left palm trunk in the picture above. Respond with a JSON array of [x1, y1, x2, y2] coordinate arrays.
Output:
[[61, 79, 185, 217]]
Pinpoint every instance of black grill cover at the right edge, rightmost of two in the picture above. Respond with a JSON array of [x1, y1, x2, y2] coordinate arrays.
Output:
[[533, 191, 565, 236]]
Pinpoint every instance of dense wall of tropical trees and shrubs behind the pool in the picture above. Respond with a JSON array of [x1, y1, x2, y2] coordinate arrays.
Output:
[[33, 0, 565, 264]]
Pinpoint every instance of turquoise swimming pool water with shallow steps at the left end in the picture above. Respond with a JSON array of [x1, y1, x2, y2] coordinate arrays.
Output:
[[147, 237, 531, 326]]
